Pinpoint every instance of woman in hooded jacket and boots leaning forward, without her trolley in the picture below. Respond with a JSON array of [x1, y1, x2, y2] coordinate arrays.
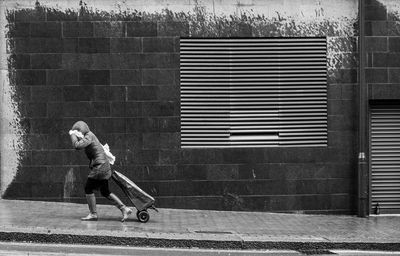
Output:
[[69, 121, 132, 222]]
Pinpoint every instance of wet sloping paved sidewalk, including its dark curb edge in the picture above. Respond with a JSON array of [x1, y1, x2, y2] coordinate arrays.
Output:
[[0, 200, 400, 250]]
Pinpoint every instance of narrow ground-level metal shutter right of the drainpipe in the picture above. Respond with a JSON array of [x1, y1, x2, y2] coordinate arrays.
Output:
[[371, 109, 400, 213]]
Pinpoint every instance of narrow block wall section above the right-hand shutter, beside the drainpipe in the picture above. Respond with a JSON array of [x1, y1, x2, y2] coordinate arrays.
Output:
[[365, 1, 400, 102]]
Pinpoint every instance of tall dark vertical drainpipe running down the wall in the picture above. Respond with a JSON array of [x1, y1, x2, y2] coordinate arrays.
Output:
[[357, 0, 369, 217]]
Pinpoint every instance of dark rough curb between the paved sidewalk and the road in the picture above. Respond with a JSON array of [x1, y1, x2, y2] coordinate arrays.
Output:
[[0, 232, 400, 251]]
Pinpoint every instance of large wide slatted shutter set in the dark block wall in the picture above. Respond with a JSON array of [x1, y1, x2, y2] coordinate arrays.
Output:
[[180, 38, 327, 148]]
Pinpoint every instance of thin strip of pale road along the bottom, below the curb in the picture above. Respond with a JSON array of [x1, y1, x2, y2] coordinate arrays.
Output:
[[0, 242, 400, 256]]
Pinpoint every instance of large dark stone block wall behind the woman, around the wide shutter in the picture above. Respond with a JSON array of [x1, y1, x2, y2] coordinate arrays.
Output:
[[1, 1, 360, 213]]
